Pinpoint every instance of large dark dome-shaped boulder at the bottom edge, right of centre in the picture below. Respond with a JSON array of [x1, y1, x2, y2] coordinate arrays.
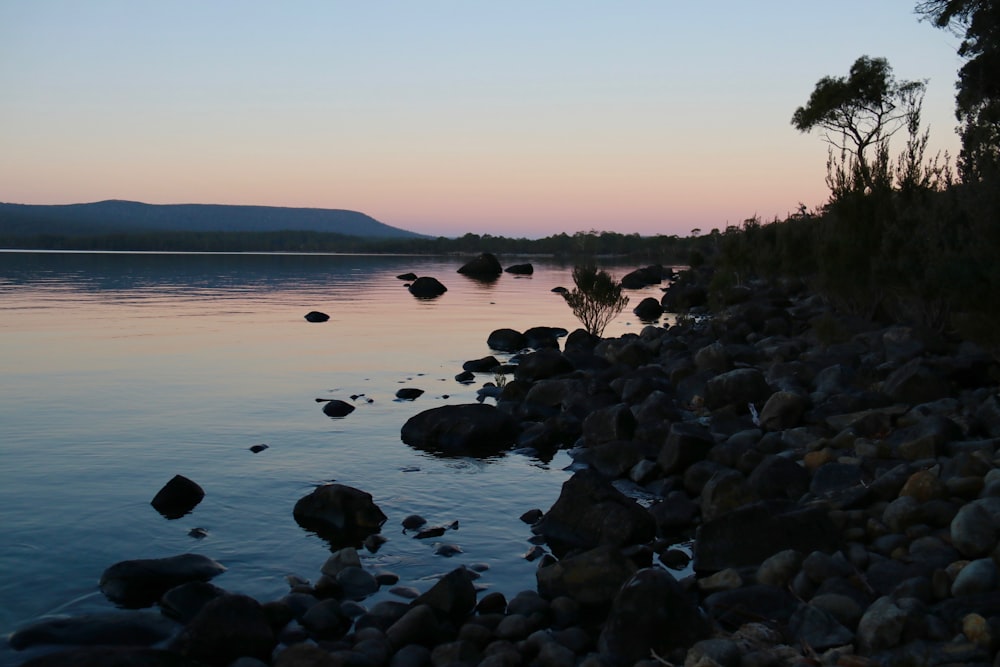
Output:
[[597, 568, 709, 665]]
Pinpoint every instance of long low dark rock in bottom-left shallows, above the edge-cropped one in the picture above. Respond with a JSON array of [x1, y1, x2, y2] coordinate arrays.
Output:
[[7, 612, 179, 651]]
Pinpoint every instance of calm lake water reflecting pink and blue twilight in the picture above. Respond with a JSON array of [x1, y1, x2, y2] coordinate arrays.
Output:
[[0, 252, 672, 664]]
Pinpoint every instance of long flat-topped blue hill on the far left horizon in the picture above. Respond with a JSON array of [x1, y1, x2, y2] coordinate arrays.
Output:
[[0, 199, 426, 239]]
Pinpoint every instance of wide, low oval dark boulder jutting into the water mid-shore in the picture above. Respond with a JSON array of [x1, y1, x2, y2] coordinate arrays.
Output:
[[400, 403, 518, 456]]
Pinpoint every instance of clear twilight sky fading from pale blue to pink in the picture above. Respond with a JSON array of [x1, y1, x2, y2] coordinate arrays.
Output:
[[0, 0, 961, 238]]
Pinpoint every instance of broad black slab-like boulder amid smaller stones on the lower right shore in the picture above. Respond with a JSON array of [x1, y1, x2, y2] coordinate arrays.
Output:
[[694, 500, 841, 573]]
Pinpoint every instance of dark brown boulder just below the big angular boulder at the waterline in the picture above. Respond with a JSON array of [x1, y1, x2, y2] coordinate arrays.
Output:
[[535, 545, 636, 609]]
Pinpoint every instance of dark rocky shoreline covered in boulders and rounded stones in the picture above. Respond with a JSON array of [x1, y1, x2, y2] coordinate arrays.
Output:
[[10, 268, 1000, 667]]
